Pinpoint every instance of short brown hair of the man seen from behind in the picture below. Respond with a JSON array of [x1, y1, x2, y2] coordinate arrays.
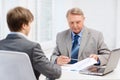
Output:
[[7, 7, 34, 32]]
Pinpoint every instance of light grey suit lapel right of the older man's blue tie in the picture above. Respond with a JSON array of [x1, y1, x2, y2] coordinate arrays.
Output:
[[78, 27, 89, 60]]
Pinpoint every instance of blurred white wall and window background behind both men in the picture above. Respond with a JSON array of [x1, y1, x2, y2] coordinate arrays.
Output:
[[0, 0, 120, 55]]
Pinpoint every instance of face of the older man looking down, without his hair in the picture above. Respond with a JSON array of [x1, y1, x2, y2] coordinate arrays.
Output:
[[67, 14, 85, 34]]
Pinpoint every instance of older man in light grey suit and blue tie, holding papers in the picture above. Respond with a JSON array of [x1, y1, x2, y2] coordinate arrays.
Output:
[[51, 8, 110, 65]]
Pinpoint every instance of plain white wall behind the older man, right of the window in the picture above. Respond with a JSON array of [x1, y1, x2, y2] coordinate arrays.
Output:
[[53, 0, 120, 49]]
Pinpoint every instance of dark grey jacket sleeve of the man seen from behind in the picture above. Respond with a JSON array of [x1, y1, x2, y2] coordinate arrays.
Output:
[[33, 44, 61, 79]]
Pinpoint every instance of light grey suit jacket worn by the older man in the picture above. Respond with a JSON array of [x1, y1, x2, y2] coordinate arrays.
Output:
[[51, 27, 110, 65]]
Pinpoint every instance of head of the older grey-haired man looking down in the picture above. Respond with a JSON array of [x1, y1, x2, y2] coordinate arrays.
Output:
[[66, 8, 85, 34]]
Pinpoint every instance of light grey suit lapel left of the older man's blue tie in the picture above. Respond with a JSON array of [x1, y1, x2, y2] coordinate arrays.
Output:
[[66, 30, 72, 57]]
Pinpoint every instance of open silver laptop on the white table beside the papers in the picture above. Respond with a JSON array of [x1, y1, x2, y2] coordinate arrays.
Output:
[[79, 49, 120, 76]]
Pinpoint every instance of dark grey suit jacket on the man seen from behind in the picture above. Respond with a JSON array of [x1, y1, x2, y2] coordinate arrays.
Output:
[[0, 34, 61, 79]]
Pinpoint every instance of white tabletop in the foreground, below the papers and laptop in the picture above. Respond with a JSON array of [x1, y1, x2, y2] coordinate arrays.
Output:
[[39, 61, 120, 80]]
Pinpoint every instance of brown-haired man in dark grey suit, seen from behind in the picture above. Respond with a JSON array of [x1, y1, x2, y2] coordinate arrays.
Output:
[[0, 7, 61, 80]]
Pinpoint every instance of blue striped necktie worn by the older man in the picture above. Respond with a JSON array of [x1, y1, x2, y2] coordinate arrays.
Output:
[[70, 35, 79, 64]]
